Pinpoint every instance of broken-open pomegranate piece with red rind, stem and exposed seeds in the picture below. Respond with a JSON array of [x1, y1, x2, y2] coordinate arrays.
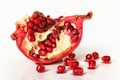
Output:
[[11, 11, 92, 64]]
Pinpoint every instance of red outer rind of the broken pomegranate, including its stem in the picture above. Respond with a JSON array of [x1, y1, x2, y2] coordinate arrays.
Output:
[[11, 12, 92, 64]]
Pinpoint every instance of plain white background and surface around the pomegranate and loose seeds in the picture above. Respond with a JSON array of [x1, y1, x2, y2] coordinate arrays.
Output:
[[0, 0, 120, 80]]
